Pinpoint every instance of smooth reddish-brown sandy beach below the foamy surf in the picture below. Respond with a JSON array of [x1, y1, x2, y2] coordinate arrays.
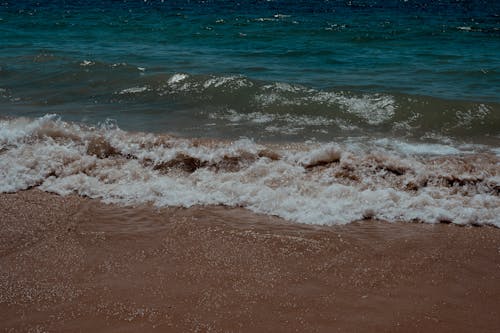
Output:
[[0, 190, 500, 332]]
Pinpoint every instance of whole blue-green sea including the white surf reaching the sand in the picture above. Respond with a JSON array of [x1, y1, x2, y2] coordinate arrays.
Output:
[[0, 0, 500, 227]]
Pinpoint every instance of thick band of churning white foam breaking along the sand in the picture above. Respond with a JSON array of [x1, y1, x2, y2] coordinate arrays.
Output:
[[0, 115, 500, 227]]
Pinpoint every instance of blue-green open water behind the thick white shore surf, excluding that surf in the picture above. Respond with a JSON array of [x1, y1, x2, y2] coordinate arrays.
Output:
[[0, 0, 500, 141]]
